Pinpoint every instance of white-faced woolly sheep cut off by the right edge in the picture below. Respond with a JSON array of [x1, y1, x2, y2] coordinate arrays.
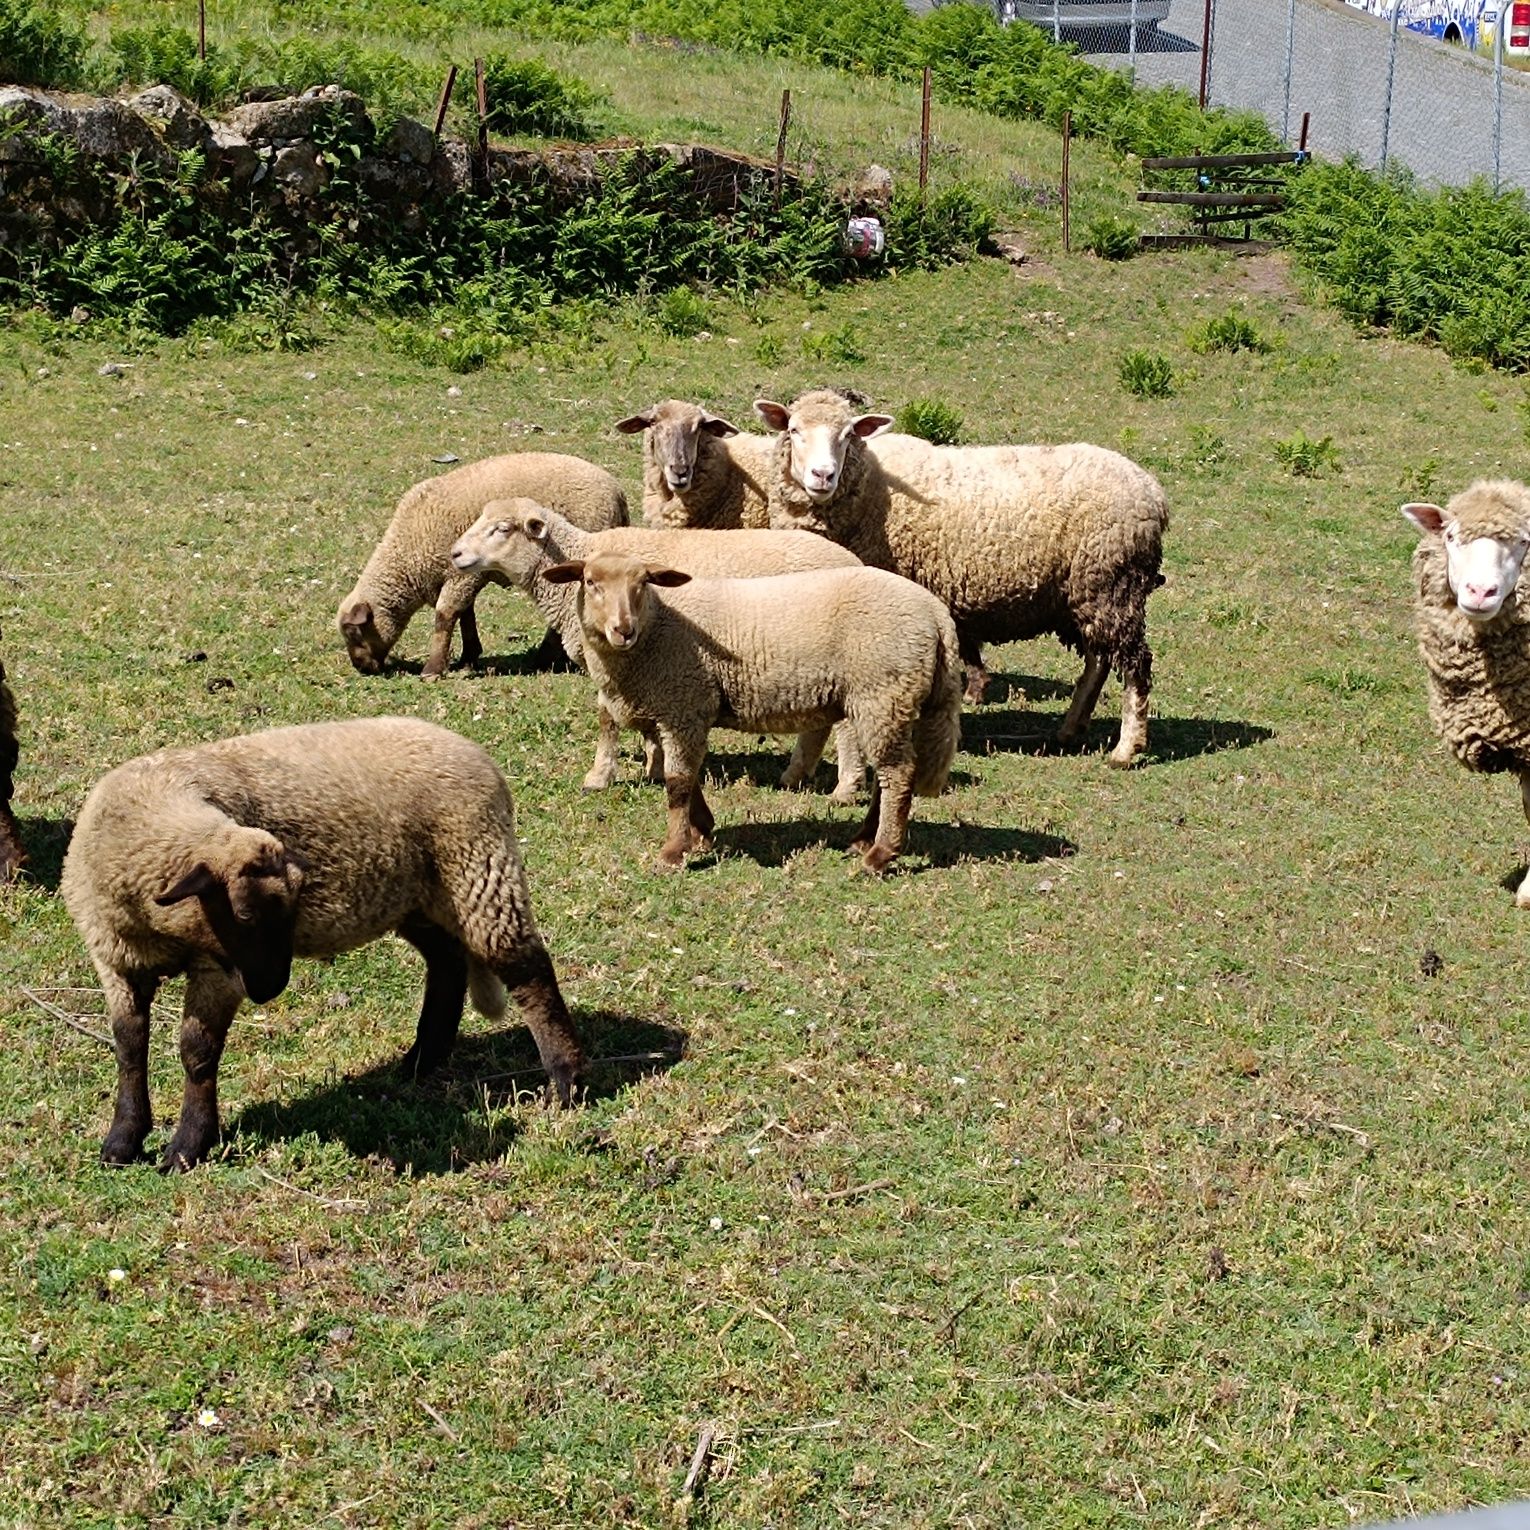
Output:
[[1403, 479, 1530, 909]]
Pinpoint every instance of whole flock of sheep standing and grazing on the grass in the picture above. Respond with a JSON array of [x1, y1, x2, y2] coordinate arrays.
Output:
[[0, 390, 1530, 1169]]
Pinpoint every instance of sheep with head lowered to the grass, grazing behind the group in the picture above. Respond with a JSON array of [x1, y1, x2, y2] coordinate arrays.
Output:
[[337, 451, 627, 679]]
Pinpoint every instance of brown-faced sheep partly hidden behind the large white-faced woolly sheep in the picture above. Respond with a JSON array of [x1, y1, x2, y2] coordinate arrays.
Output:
[[617, 398, 776, 531]]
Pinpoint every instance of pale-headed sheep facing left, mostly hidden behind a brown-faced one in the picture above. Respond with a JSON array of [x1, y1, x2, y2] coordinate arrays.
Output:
[[451, 499, 864, 802]]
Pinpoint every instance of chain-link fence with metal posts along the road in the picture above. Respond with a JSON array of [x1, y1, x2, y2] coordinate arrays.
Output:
[[966, 0, 1530, 188]]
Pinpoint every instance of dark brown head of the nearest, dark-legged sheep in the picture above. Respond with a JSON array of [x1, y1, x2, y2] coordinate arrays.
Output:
[[155, 823, 308, 1004]]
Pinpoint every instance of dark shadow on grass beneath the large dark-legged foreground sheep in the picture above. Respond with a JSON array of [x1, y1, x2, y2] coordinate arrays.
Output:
[[223, 1010, 687, 1177]]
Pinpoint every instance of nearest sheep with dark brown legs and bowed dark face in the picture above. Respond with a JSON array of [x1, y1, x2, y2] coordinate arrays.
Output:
[[61, 718, 583, 1169]]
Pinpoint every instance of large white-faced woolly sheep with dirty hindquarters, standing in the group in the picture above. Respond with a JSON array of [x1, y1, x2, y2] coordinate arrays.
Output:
[[754, 392, 1169, 767]]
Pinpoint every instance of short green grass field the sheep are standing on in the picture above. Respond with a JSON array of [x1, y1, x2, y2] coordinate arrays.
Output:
[[0, 17, 1530, 1530]]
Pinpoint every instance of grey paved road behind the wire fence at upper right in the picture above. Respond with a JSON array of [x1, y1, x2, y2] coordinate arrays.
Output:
[[1052, 0, 1530, 188]]
